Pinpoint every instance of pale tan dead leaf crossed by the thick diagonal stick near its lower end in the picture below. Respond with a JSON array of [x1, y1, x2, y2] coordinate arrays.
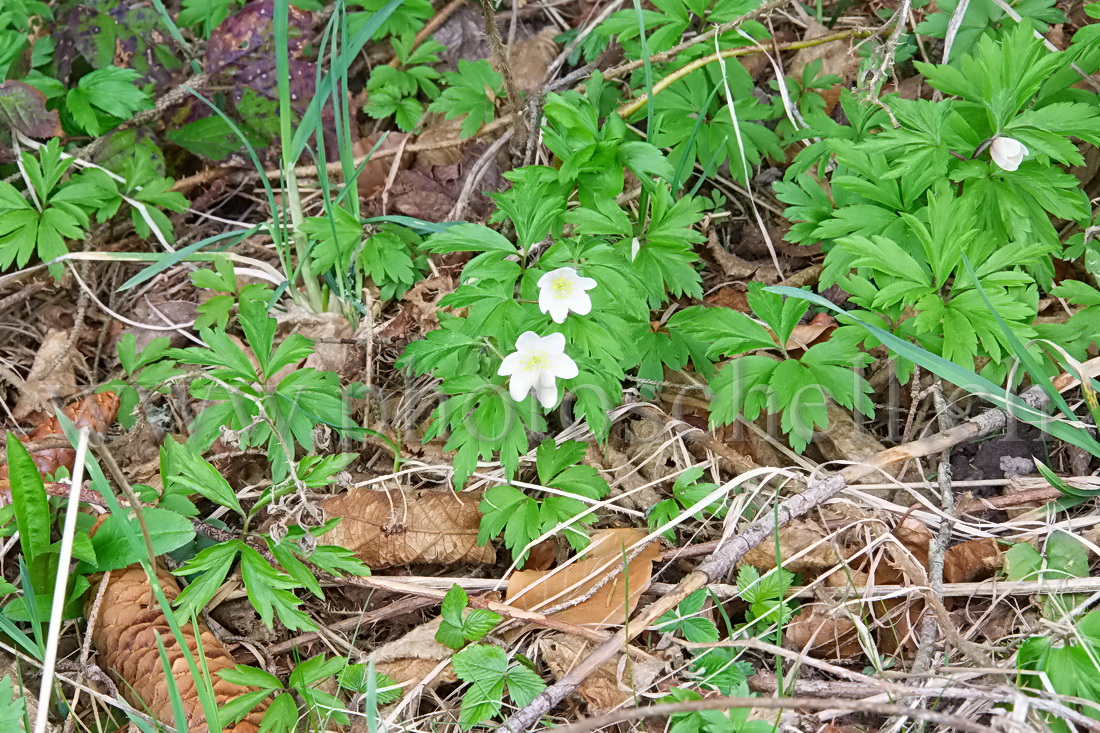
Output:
[[539, 634, 663, 715]]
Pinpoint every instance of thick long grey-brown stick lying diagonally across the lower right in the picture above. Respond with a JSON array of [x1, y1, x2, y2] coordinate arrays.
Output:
[[496, 358, 1100, 733]]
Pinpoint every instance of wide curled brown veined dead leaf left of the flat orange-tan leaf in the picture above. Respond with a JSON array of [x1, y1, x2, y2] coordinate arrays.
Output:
[[321, 489, 496, 568]]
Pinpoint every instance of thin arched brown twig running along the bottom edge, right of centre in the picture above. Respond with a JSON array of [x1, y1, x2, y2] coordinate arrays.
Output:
[[554, 698, 997, 733]]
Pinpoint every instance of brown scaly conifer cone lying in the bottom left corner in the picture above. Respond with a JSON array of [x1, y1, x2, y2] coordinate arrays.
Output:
[[85, 565, 266, 733]]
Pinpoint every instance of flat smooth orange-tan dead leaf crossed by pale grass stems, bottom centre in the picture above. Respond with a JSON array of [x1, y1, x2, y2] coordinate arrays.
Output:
[[505, 528, 660, 626]]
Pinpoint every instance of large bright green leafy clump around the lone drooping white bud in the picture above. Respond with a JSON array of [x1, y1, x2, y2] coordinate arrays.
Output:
[[776, 28, 1100, 382]]
